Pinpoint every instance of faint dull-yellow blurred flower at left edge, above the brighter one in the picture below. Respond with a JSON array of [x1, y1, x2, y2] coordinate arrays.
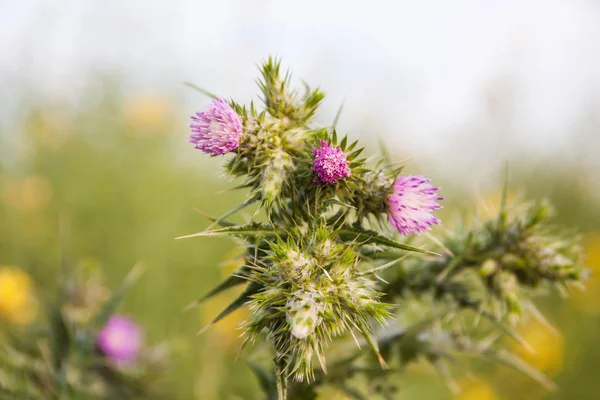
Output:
[[2, 175, 52, 211]]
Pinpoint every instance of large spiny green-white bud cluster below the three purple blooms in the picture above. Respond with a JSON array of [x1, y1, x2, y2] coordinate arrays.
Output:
[[245, 226, 389, 381]]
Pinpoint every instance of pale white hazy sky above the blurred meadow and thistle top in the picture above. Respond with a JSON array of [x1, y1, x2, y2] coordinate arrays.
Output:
[[0, 0, 600, 180]]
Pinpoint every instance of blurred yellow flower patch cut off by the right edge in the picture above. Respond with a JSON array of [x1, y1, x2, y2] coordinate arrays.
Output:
[[570, 232, 600, 314]]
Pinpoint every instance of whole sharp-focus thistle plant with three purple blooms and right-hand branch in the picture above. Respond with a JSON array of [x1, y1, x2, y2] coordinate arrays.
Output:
[[182, 59, 583, 399]]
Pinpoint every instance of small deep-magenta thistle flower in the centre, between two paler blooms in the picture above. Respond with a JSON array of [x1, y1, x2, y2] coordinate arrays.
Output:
[[313, 140, 350, 186]]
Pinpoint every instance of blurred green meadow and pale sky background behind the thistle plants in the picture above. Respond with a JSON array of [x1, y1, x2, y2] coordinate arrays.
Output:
[[0, 0, 600, 400]]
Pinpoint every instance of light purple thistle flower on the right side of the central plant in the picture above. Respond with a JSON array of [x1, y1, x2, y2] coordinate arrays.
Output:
[[388, 175, 444, 236]]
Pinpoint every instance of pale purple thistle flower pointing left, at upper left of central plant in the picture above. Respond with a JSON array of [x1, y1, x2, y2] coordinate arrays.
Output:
[[190, 99, 242, 156]]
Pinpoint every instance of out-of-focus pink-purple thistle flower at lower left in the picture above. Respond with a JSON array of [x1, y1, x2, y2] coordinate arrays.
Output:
[[96, 316, 142, 364]]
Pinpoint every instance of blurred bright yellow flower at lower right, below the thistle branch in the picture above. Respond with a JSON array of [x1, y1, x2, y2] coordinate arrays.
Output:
[[514, 321, 565, 376]]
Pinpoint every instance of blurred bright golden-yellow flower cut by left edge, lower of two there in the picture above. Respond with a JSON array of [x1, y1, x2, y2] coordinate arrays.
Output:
[[0, 266, 37, 325]]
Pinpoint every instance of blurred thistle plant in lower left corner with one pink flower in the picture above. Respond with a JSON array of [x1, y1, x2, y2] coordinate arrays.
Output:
[[0, 267, 165, 400]]
